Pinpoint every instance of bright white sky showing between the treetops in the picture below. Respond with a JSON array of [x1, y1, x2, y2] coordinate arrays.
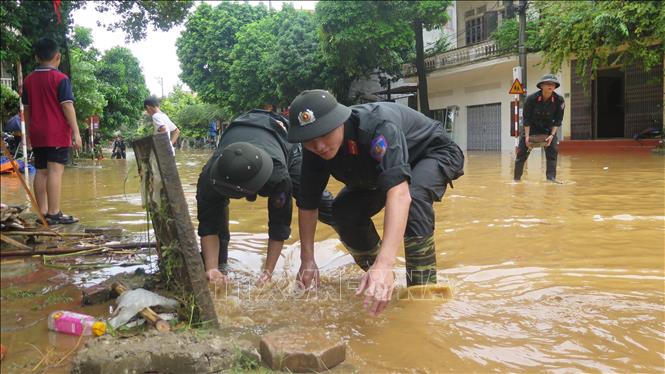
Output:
[[73, 1, 316, 96]]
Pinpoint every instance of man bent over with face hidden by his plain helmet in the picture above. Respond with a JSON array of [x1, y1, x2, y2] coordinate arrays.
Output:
[[196, 109, 332, 284]]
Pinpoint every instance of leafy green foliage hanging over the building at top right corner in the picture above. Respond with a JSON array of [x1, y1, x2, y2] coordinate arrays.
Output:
[[492, 0, 665, 77]]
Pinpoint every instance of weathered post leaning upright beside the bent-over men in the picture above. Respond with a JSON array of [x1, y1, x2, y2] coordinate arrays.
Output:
[[132, 134, 219, 327]]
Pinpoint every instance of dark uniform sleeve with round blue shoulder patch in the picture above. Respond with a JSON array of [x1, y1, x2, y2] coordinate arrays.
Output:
[[370, 122, 411, 192]]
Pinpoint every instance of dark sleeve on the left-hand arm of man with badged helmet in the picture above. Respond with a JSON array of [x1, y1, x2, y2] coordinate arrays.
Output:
[[296, 149, 330, 210]]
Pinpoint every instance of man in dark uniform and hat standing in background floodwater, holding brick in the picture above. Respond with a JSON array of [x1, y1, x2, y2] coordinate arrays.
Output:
[[515, 74, 566, 183]]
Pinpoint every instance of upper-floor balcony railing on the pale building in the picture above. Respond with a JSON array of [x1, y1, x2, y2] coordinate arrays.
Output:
[[402, 40, 511, 76]]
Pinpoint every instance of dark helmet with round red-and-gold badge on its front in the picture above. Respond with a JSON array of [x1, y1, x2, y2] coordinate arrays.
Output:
[[288, 90, 351, 143]]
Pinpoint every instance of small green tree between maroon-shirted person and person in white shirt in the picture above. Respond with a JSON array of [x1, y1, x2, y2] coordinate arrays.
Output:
[[96, 47, 149, 135]]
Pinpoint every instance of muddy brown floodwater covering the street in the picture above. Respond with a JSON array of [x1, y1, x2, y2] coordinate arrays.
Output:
[[1, 151, 665, 373]]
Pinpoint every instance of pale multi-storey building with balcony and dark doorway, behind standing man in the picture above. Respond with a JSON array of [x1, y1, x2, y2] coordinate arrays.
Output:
[[404, 1, 665, 151]]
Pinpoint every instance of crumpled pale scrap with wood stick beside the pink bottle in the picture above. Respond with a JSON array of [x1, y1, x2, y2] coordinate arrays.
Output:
[[109, 284, 178, 331]]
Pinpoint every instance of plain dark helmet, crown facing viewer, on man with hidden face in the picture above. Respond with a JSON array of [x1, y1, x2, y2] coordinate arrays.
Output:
[[210, 142, 273, 198]]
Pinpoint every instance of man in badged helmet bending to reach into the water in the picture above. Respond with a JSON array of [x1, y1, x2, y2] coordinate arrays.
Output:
[[288, 90, 464, 315]]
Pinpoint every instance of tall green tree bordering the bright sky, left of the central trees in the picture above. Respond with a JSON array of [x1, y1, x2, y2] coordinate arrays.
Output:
[[176, 2, 268, 105]]
